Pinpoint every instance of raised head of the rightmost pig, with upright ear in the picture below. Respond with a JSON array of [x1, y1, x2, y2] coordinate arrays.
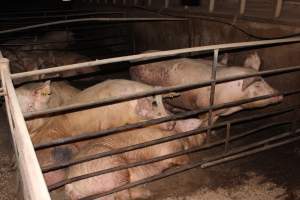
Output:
[[242, 53, 283, 108]]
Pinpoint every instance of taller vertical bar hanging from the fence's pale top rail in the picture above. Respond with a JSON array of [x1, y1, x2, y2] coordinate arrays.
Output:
[[207, 49, 219, 141]]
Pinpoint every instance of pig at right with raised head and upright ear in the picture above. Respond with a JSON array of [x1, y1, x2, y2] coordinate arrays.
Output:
[[130, 53, 283, 124]]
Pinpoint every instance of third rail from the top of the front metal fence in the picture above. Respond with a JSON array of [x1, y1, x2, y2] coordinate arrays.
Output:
[[35, 89, 300, 150]]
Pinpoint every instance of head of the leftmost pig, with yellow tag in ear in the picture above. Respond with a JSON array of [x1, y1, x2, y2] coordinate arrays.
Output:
[[16, 81, 51, 132]]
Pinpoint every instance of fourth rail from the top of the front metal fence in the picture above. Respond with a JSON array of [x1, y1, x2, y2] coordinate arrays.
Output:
[[43, 105, 291, 172]]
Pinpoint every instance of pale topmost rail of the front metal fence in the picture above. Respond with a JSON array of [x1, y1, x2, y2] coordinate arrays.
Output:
[[12, 37, 300, 79]]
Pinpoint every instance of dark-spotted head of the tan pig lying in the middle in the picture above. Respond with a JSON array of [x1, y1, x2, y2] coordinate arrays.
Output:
[[135, 95, 175, 130]]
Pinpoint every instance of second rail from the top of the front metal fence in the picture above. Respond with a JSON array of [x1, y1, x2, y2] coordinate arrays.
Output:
[[24, 66, 300, 119]]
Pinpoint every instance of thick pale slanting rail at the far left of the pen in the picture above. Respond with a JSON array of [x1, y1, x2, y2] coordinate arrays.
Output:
[[0, 58, 50, 200]]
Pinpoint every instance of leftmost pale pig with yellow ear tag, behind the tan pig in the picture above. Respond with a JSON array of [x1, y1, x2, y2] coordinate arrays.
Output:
[[16, 81, 80, 133]]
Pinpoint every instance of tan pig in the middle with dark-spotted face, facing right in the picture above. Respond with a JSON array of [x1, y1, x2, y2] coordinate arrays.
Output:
[[49, 79, 174, 134]]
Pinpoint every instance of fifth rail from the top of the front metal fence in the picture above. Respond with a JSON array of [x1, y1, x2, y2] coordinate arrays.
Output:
[[47, 122, 290, 191]]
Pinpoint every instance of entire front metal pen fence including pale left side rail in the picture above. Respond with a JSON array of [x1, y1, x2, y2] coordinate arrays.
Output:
[[1, 37, 300, 199]]
